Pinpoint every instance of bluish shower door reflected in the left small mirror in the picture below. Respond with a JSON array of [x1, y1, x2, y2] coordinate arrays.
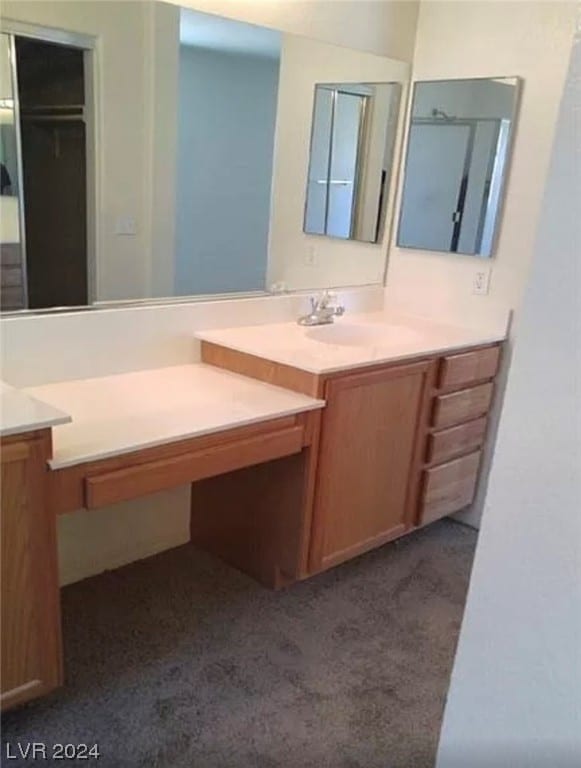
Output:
[[305, 86, 368, 239]]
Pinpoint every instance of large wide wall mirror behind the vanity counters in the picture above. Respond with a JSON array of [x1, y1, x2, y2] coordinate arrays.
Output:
[[0, 0, 409, 311]]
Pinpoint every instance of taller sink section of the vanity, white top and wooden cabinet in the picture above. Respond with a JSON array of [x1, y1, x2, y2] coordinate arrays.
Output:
[[200, 321, 501, 574]]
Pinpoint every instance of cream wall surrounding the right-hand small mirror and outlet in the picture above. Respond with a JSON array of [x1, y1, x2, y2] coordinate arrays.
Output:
[[386, 0, 576, 524]]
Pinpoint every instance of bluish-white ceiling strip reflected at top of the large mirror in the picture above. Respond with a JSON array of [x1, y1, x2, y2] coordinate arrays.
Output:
[[180, 8, 282, 59]]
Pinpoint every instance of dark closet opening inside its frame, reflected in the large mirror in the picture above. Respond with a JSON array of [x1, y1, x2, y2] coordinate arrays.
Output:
[[15, 37, 88, 309]]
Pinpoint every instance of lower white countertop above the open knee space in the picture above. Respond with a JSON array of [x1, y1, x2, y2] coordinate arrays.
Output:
[[23, 363, 325, 469]]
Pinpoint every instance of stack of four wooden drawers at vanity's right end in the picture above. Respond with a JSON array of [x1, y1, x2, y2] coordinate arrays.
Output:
[[418, 345, 500, 525]]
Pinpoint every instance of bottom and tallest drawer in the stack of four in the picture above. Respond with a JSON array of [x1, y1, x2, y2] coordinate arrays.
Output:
[[420, 451, 480, 525]]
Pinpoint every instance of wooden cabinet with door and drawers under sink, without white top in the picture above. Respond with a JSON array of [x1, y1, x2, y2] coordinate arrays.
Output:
[[202, 342, 501, 575]]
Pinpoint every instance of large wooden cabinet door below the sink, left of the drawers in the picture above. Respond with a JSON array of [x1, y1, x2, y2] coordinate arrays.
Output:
[[310, 362, 434, 572]]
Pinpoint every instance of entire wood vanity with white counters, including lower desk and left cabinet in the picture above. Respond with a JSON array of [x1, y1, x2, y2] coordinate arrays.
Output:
[[1, 317, 502, 708]]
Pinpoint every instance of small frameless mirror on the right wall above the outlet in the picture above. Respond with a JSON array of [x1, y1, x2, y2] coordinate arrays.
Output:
[[397, 77, 520, 257]]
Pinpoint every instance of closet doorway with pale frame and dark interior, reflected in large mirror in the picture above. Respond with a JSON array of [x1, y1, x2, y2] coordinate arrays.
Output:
[[2, 22, 96, 310]]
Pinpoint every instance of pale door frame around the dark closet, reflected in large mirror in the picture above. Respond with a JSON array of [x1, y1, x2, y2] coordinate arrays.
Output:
[[0, 19, 101, 304]]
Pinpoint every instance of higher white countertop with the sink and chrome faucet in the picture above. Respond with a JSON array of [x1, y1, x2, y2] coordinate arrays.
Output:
[[196, 312, 506, 374]]
